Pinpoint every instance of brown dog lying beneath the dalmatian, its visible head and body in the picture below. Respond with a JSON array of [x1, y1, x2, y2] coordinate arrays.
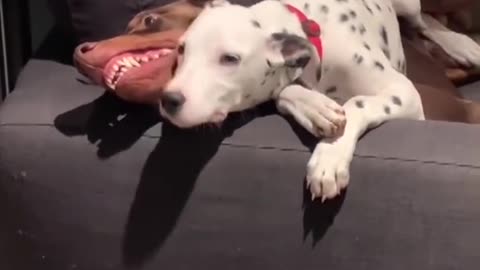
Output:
[[74, 0, 480, 123]]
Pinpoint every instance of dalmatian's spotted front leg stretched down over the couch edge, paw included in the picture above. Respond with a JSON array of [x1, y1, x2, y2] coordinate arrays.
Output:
[[307, 71, 424, 201]]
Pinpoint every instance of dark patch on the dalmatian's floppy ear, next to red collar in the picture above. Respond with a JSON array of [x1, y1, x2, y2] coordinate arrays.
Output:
[[272, 33, 313, 68]]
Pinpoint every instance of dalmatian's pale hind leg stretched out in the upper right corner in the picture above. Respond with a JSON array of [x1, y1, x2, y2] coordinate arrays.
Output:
[[392, 0, 480, 68]]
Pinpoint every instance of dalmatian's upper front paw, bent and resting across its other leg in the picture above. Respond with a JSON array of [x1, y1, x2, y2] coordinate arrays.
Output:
[[275, 85, 346, 137]]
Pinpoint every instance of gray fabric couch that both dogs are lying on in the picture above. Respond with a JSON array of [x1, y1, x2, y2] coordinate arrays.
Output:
[[0, 0, 480, 270]]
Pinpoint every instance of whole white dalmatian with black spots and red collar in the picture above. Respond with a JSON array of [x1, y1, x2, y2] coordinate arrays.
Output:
[[159, 0, 480, 201]]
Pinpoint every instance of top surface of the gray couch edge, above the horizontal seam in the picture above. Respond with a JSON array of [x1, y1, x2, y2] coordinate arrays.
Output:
[[0, 60, 480, 166]]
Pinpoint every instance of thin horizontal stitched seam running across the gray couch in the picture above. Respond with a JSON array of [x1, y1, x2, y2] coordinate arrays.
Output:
[[0, 123, 480, 169]]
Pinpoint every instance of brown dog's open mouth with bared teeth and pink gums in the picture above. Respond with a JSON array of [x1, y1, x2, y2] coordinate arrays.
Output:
[[103, 48, 173, 90]]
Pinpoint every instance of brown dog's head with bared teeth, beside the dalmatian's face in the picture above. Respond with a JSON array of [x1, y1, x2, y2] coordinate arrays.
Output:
[[74, 0, 203, 104]]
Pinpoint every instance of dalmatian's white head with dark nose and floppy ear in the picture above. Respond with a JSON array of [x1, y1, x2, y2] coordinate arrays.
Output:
[[160, 1, 313, 128]]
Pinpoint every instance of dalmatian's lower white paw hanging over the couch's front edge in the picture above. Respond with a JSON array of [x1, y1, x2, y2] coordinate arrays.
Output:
[[307, 140, 352, 202]]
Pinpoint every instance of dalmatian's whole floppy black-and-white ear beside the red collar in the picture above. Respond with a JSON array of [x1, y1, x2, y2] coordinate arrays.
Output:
[[267, 33, 313, 68]]
